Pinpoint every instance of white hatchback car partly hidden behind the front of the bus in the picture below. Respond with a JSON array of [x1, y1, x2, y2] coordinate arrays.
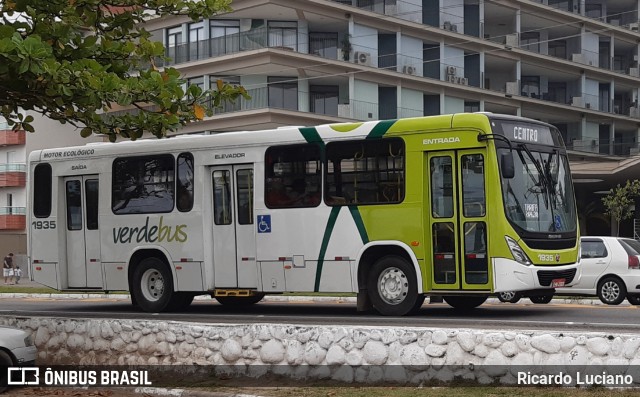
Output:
[[498, 236, 640, 305]]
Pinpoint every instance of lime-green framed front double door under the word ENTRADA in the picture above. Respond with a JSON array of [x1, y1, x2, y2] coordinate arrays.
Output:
[[425, 150, 490, 290]]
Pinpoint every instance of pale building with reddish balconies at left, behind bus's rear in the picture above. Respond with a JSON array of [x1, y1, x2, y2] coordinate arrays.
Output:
[[0, 114, 102, 255]]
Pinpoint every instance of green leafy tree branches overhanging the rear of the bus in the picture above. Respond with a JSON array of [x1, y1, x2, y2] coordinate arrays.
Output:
[[0, 0, 248, 141]]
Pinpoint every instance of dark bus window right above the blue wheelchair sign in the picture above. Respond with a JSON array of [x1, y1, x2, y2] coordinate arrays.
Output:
[[264, 144, 322, 208]]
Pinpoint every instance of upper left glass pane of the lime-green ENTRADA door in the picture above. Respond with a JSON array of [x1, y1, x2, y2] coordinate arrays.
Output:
[[430, 156, 453, 218]]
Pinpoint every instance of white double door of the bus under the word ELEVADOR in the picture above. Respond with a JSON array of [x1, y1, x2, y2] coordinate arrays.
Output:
[[211, 164, 258, 288]]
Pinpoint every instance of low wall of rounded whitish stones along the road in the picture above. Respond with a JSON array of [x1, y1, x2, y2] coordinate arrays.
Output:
[[0, 316, 640, 384]]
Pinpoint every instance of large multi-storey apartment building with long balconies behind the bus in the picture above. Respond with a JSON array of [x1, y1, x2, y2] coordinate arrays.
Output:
[[139, 0, 640, 233]]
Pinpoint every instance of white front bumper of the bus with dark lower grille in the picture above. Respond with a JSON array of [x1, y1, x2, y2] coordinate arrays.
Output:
[[493, 258, 581, 292]]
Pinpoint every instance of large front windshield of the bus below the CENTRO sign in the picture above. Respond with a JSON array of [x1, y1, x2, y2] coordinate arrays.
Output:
[[499, 143, 576, 233]]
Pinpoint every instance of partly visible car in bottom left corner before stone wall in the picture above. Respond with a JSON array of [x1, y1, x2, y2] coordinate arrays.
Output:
[[0, 326, 36, 393]]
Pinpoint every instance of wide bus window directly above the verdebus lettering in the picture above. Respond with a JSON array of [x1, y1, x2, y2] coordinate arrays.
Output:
[[111, 154, 175, 215]]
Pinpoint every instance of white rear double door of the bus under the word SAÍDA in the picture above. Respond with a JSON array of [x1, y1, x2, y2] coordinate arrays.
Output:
[[64, 175, 102, 288]]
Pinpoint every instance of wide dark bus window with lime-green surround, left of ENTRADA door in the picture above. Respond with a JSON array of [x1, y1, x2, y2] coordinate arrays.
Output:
[[325, 138, 405, 205]]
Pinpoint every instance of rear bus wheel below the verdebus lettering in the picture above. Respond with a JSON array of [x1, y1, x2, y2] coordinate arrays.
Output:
[[131, 257, 174, 313]]
